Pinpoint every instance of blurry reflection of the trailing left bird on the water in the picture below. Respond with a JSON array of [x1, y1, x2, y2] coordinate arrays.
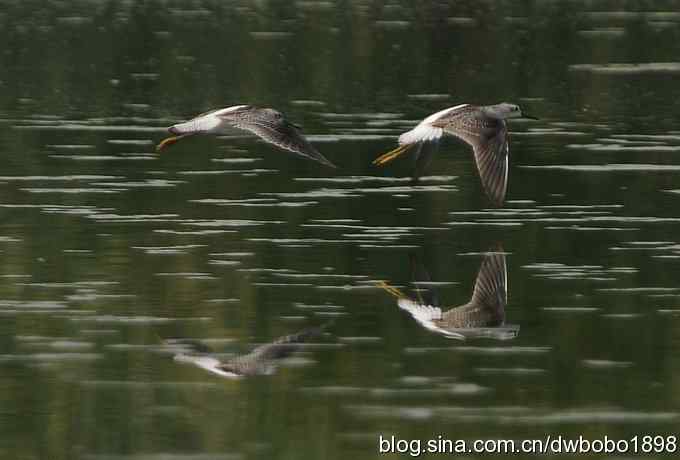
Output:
[[165, 324, 328, 378]]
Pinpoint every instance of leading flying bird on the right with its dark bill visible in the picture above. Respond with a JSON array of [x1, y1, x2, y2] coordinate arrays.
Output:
[[373, 102, 536, 206]]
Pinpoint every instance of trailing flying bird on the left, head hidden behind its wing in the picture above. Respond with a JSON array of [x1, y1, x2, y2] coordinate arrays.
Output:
[[156, 105, 335, 168]]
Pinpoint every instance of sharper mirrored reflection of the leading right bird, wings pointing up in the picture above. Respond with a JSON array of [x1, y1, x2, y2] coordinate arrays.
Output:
[[378, 247, 519, 340]]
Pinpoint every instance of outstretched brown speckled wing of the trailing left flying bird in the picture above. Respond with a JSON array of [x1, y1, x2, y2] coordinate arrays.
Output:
[[219, 108, 336, 168]]
